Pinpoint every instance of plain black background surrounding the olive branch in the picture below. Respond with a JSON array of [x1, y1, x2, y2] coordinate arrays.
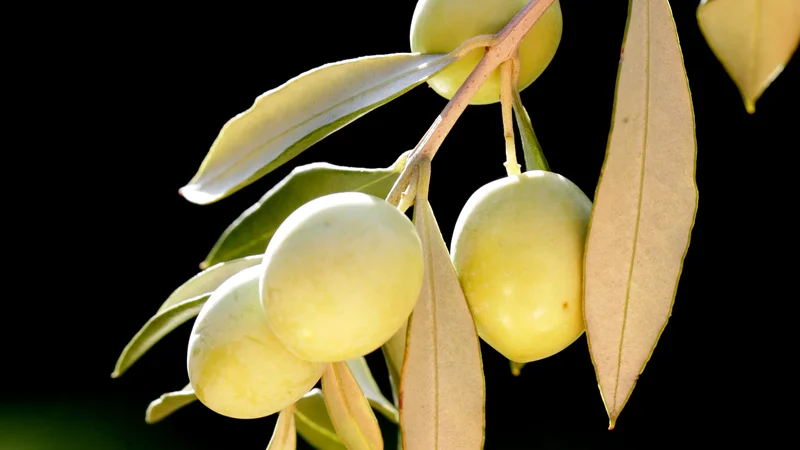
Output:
[[0, 0, 800, 450]]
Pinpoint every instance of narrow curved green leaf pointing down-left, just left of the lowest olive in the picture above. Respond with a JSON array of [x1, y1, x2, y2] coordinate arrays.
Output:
[[111, 294, 210, 378]]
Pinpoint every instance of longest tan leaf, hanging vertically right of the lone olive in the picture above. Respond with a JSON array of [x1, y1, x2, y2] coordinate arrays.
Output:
[[584, 0, 698, 429]]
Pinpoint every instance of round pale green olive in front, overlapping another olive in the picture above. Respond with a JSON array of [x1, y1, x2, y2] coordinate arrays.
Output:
[[261, 192, 423, 362]]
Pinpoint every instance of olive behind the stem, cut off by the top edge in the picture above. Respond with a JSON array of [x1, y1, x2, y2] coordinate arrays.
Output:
[[411, 0, 562, 105]]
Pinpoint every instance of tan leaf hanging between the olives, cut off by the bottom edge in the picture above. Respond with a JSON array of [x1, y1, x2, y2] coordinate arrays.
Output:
[[400, 200, 486, 450]]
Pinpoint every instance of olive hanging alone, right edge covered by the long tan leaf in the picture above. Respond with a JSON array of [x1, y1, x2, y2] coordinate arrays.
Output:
[[451, 170, 592, 362]]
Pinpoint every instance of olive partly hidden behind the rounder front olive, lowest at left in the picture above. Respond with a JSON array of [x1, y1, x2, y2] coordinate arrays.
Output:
[[188, 266, 325, 419]]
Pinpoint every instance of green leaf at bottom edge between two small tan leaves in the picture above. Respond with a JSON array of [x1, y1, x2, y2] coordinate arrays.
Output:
[[294, 388, 347, 450]]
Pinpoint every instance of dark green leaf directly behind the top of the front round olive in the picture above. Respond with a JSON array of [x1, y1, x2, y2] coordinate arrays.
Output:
[[200, 152, 409, 268]]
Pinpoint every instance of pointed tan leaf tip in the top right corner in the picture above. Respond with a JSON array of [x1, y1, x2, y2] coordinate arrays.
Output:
[[697, 0, 800, 114]]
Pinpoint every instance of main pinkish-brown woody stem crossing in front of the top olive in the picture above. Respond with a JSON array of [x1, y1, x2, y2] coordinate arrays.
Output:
[[386, 0, 555, 205]]
